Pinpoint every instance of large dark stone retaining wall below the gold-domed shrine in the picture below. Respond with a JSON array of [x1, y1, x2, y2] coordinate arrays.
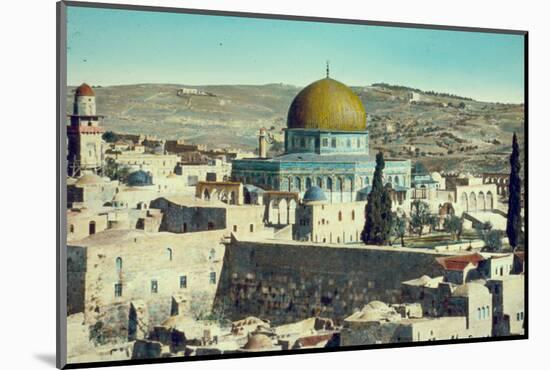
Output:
[[216, 240, 450, 324]]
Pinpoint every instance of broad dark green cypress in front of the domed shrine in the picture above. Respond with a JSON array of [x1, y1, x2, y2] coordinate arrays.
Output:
[[361, 152, 392, 245]]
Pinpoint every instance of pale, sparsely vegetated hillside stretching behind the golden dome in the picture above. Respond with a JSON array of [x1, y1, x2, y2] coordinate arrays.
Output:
[[67, 84, 524, 172]]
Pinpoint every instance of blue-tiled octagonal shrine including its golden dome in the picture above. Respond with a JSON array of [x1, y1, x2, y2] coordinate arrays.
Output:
[[231, 75, 411, 203]]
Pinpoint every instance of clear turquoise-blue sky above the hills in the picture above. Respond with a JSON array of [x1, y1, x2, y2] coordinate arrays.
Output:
[[67, 7, 524, 103]]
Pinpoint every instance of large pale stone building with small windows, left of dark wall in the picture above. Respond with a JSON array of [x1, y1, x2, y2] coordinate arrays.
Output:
[[67, 230, 225, 340]]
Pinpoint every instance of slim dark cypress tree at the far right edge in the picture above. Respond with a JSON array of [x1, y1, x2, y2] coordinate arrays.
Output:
[[506, 133, 521, 250]]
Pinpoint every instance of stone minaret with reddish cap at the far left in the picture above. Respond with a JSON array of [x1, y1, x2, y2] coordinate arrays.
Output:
[[67, 83, 104, 176]]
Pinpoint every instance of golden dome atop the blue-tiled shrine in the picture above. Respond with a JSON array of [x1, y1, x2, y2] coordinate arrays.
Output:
[[287, 77, 367, 131]]
